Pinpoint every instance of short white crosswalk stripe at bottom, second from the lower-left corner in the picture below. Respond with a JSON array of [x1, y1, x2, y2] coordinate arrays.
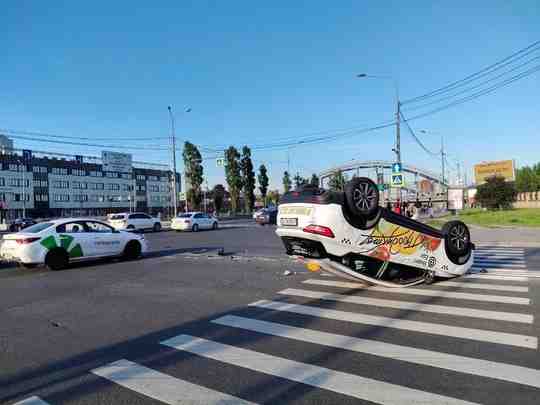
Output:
[[92, 359, 253, 405]]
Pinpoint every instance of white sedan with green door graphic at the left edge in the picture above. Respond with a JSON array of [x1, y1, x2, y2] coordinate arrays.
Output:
[[0, 218, 148, 270]]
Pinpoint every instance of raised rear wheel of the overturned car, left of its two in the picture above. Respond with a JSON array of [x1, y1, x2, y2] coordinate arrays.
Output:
[[345, 177, 379, 218]]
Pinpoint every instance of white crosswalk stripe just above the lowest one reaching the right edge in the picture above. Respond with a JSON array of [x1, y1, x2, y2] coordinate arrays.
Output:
[[249, 300, 538, 350]]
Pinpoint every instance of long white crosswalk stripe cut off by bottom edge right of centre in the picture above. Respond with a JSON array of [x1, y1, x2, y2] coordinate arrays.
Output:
[[161, 335, 480, 405]]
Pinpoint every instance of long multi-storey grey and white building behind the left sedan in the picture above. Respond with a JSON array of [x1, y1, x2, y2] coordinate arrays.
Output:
[[0, 148, 181, 218]]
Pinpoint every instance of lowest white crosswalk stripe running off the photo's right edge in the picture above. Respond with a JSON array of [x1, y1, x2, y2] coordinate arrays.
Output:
[[212, 315, 540, 388]]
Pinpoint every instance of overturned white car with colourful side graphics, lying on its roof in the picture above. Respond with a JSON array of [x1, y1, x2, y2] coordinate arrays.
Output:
[[276, 177, 474, 287]]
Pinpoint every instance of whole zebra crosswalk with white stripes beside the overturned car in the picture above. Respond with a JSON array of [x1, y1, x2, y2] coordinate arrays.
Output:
[[11, 247, 540, 405]]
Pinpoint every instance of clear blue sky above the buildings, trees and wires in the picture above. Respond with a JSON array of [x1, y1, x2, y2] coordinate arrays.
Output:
[[0, 0, 540, 187]]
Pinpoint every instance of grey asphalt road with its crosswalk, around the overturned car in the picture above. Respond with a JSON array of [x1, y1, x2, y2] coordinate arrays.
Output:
[[0, 221, 540, 405]]
